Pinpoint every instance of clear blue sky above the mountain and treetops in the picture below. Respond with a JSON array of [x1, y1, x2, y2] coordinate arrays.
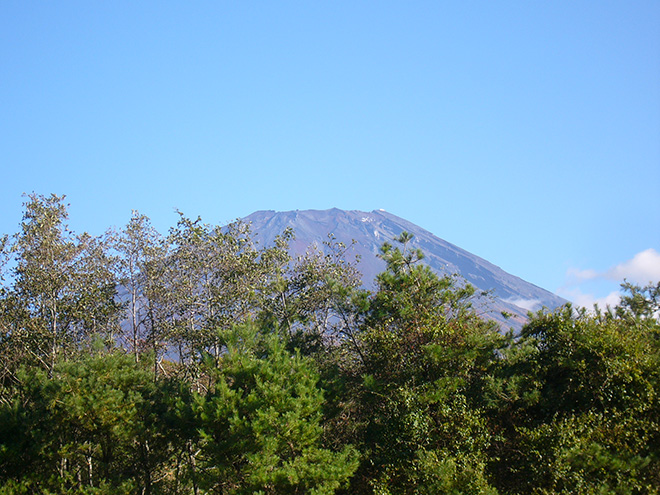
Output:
[[0, 0, 660, 308]]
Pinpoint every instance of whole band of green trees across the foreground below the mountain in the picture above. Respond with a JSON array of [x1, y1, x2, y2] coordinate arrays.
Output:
[[0, 194, 660, 495]]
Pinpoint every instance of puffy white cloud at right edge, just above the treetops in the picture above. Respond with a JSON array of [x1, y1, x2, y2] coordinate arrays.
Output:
[[557, 249, 660, 308]]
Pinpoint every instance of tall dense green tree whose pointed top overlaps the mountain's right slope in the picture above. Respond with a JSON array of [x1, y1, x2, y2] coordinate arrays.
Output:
[[340, 232, 499, 493]]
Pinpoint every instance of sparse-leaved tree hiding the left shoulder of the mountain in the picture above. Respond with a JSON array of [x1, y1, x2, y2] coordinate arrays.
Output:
[[168, 214, 283, 376]]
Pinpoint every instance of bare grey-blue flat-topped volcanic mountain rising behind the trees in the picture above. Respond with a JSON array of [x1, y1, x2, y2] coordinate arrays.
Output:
[[243, 208, 567, 330]]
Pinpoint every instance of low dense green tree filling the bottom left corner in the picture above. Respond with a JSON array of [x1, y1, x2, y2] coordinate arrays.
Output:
[[0, 352, 186, 494]]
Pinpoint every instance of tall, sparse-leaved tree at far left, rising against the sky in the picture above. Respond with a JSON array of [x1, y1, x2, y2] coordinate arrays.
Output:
[[2, 194, 120, 384]]
